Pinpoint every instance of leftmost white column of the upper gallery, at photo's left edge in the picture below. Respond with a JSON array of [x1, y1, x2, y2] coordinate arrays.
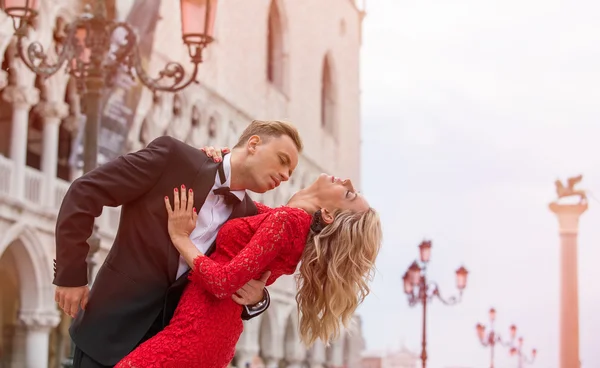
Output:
[[2, 86, 40, 200]]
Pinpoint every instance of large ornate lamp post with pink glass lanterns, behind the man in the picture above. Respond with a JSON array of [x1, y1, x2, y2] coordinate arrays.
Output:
[[0, 0, 217, 367]]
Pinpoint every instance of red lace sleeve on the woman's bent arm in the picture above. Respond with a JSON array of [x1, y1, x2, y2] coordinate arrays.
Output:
[[190, 209, 299, 299]]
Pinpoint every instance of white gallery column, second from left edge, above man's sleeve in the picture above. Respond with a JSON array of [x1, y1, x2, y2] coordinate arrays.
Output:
[[36, 101, 69, 207]]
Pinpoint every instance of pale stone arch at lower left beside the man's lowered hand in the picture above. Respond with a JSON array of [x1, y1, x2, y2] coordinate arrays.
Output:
[[0, 222, 56, 313]]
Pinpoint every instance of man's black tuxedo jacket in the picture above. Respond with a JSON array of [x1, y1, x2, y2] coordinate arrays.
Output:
[[53, 136, 268, 365]]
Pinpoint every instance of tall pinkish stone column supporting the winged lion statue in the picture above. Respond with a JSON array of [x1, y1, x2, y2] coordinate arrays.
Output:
[[550, 202, 588, 368]]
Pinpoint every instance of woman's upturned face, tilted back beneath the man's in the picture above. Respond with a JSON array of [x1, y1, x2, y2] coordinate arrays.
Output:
[[313, 174, 370, 223]]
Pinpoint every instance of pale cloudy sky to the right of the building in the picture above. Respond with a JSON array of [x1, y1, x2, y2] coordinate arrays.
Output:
[[359, 0, 600, 368]]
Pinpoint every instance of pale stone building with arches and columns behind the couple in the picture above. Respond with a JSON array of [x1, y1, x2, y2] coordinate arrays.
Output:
[[0, 0, 366, 368]]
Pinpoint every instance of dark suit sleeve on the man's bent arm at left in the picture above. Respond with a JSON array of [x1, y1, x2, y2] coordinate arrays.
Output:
[[53, 136, 175, 287]]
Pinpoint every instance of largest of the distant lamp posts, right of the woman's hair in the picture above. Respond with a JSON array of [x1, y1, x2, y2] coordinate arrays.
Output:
[[403, 241, 469, 368]]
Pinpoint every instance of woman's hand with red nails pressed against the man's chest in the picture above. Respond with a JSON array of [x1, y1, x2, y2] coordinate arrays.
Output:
[[165, 185, 198, 243]]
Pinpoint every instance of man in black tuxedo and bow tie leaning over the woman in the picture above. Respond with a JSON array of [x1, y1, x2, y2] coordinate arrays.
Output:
[[54, 121, 302, 368]]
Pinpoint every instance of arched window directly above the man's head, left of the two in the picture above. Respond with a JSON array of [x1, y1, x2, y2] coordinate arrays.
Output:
[[267, 0, 285, 91]]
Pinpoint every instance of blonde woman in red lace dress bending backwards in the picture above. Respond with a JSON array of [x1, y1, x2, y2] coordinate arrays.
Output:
[[116, 170, 381, 368]]
